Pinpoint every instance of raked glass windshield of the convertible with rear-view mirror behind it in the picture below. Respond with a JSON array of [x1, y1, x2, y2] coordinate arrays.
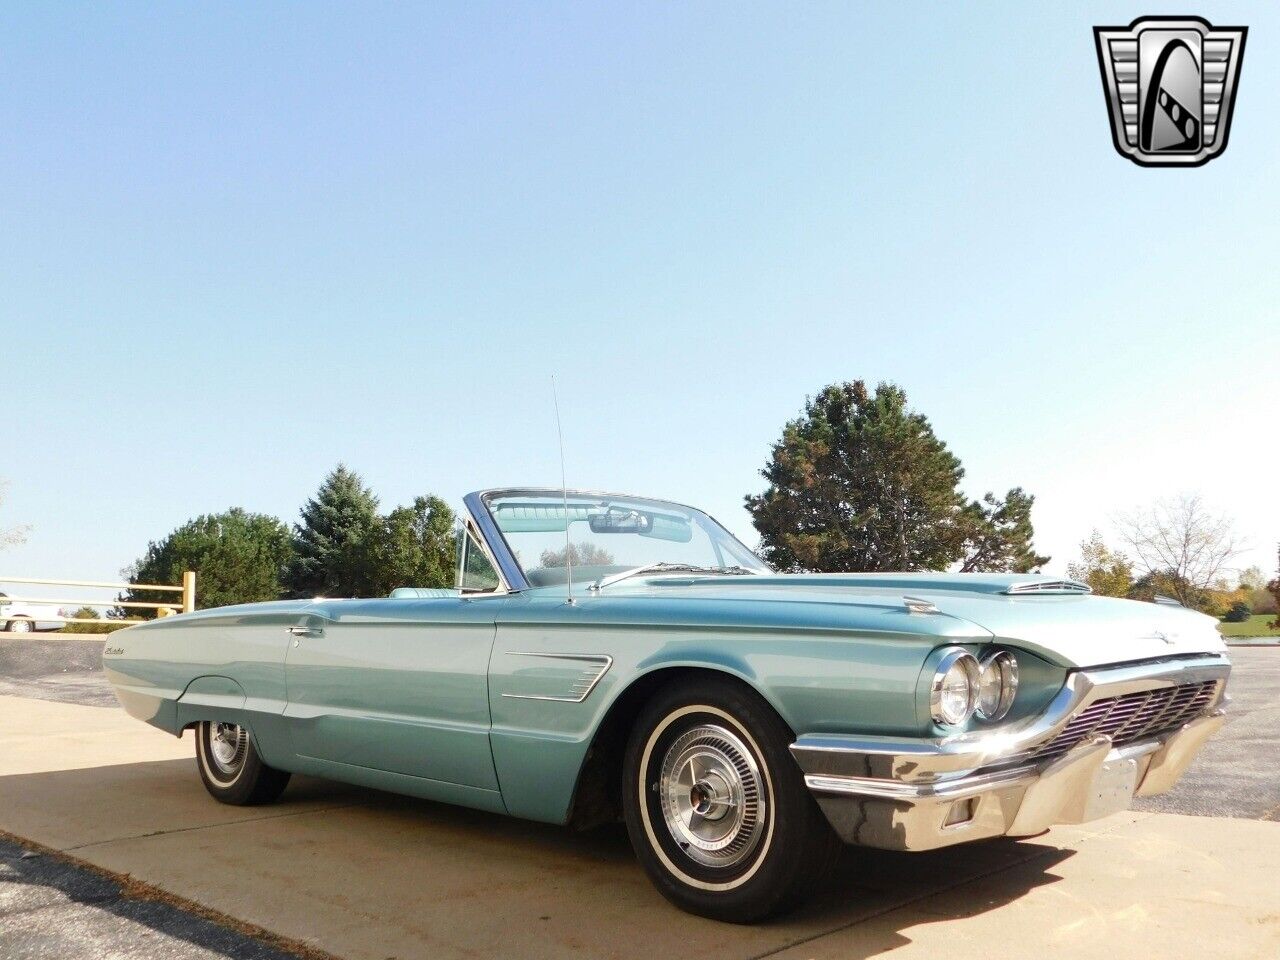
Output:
[[484, 492, 769, 586]]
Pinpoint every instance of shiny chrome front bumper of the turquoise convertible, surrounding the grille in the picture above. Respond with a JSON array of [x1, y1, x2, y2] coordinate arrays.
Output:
[[791, 655, 1230, 850]]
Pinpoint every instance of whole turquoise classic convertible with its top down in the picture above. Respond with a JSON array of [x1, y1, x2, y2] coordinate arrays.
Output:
[[104, 489, 1230, 922]]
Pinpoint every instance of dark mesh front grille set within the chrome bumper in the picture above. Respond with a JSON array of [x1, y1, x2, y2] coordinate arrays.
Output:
[[1028, 680, 1221, 760]]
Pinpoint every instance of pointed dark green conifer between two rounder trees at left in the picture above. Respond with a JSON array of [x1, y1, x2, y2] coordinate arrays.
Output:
[[285, 463, 381, 596]]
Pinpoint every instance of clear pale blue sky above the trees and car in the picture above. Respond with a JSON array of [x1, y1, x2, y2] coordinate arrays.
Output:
[[0, 3, 1280, 601]]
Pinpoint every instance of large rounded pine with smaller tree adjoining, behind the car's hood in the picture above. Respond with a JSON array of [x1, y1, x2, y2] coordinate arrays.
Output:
[[746, 380, 1047, 572]]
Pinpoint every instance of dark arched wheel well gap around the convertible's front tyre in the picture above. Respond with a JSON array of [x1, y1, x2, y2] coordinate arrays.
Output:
[[568, 667, 773, 829]]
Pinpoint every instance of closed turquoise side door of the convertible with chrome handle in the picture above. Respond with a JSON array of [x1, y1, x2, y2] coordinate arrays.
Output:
[[285, 596, 503, 794]]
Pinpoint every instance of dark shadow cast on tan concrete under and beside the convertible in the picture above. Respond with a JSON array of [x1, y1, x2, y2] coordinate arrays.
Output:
[[0, 760, 1073, 960]]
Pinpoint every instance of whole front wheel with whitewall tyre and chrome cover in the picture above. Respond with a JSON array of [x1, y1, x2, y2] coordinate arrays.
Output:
[[623, 678, 840, 923]]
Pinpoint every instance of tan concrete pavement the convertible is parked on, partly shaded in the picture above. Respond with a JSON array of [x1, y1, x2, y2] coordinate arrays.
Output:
[[0, 698, 1280, 960]]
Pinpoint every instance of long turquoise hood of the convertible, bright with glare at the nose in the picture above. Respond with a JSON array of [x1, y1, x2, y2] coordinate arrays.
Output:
[[604, 573, 1226, 667]]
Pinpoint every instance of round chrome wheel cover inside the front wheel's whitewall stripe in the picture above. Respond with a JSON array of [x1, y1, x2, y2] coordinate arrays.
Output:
[[658, 724, 767, 867]]
